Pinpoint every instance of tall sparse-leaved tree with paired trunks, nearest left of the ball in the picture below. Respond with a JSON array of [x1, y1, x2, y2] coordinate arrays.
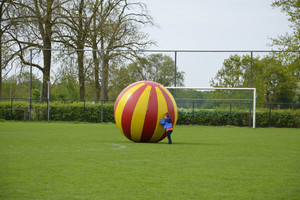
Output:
[[89, 0, 154, 101]]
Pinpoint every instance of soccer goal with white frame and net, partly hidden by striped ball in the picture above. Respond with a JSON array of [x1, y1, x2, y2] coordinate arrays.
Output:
[[167, 87, 256, 128]]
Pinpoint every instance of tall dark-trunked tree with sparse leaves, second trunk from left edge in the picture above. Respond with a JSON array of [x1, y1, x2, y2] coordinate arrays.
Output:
[[10, 0, 68, 99]]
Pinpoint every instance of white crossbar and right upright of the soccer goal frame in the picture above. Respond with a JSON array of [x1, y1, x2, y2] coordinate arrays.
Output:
[[166, 87, 256, 128]]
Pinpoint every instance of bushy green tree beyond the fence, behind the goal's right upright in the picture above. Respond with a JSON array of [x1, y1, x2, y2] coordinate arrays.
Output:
[[211, 55, 299, 103]]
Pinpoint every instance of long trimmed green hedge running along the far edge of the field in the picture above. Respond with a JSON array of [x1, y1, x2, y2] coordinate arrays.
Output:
[[0, 101, 300, 128]]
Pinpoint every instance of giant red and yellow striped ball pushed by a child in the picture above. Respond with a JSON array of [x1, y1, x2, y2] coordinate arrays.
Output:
[[114, 81, 178, 142]]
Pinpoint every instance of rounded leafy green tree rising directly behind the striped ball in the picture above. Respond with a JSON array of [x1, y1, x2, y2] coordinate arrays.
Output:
[[111, 54, 184, 98]]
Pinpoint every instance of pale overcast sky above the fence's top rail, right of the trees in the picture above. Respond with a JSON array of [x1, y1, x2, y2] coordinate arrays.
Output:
[[142, 0, 289, 50]]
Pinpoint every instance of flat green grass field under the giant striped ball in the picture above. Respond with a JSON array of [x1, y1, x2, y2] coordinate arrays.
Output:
[[0, 122, 300, 200]]
